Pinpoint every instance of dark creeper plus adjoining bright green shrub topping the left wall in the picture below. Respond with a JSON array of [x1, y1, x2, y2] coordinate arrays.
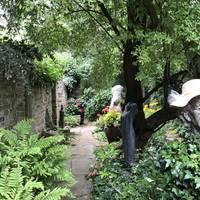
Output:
[[0, 39, 64, 87]]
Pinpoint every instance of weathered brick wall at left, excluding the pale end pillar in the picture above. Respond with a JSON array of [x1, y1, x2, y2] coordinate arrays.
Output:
[[0, 77, 52, 132]]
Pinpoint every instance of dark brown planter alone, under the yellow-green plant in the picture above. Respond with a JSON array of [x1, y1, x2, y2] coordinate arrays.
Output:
[[104, 126, 122, 143]]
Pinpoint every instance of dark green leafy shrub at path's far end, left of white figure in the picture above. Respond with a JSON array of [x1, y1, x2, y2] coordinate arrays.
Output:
[[85, 90, 112, 121]]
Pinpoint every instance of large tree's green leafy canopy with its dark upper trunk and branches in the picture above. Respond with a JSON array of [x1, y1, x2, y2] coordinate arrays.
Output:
[[0, 0, 200, 147]]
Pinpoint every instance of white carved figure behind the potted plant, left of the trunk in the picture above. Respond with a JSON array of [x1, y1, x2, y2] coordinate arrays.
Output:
[[109, 85, 124, 112]]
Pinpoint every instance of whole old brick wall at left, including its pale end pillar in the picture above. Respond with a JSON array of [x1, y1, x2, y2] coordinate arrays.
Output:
[[0, 76, 67, 132]]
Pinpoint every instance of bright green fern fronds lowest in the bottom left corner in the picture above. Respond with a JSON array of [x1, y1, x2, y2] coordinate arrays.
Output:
[[0, 167, 71, 200]]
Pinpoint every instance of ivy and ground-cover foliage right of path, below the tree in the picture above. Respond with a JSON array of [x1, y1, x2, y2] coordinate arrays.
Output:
[[94, 119, 200, 200]]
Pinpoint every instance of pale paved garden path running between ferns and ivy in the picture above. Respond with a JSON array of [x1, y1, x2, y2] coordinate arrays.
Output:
[[69, 124, 98, 200]]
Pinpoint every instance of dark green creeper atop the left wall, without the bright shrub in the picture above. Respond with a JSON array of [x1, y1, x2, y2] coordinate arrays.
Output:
[[0, 40, 42, 85]]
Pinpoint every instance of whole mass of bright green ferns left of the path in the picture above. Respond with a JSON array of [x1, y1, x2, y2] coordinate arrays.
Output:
[[0, 121, 74, 200]]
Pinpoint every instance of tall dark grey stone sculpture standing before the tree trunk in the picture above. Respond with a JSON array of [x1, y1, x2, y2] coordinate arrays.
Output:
[[121, 103, 138, 165]]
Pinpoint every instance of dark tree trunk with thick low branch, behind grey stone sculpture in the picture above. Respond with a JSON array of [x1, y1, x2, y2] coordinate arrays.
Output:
[[123, 0, 176, 147]]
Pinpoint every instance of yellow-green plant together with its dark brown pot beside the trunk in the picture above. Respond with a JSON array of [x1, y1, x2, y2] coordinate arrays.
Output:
[[102, 111, 121, 143]]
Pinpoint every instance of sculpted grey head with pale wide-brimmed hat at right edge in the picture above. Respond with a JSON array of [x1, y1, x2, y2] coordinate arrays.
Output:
[[168, 79, 200, 133]]
